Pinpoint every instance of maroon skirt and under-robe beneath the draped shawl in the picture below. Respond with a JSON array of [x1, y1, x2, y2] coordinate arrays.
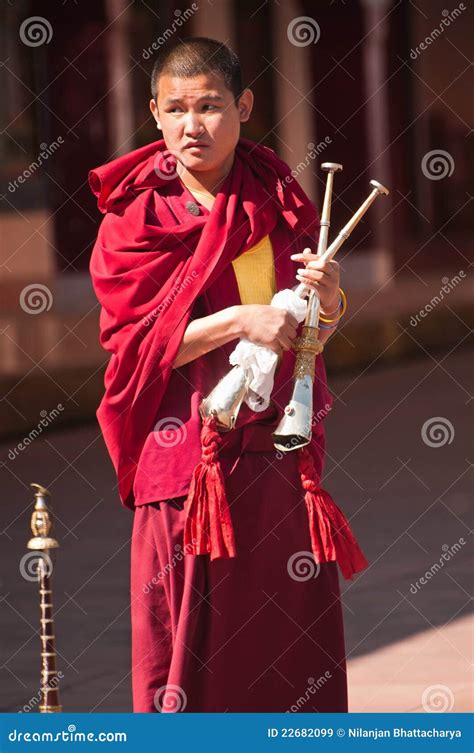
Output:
[[131, 195, 347, 712]]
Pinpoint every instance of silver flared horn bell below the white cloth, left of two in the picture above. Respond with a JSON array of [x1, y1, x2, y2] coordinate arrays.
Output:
[[199, 366, 250, 431]]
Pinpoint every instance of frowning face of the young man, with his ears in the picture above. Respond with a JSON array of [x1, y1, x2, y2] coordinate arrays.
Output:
[[150, 73, 253, 172]]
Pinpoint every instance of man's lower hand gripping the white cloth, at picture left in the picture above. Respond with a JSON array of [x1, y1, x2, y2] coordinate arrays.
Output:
[[237, 304, 298, 355]]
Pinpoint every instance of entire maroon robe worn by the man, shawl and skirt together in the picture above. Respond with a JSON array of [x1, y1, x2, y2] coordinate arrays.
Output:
[[91, 140, 366, 712]]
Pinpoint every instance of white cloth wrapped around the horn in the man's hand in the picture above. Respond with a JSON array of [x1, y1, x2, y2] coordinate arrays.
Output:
[[229, 289, 308, 412]]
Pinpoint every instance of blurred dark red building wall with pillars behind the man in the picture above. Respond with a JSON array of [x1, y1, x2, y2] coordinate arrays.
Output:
[[0, 0, 473, 433]]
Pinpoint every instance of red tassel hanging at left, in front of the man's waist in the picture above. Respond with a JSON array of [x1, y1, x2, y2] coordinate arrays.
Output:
[[184, 417, 237, 560]]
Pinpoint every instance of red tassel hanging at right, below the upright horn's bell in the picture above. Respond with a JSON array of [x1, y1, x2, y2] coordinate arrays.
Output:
[[298, 447, 369, 580]]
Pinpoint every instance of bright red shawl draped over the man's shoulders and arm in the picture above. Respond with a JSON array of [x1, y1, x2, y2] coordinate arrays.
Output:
[[89, 138, 365, 571]]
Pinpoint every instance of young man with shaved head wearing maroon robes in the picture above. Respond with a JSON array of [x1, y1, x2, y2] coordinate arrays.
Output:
[[90, 38, 367, 712]]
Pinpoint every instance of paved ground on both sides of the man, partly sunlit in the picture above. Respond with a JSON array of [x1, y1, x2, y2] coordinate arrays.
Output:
[[0, 347, 474, 711]]
